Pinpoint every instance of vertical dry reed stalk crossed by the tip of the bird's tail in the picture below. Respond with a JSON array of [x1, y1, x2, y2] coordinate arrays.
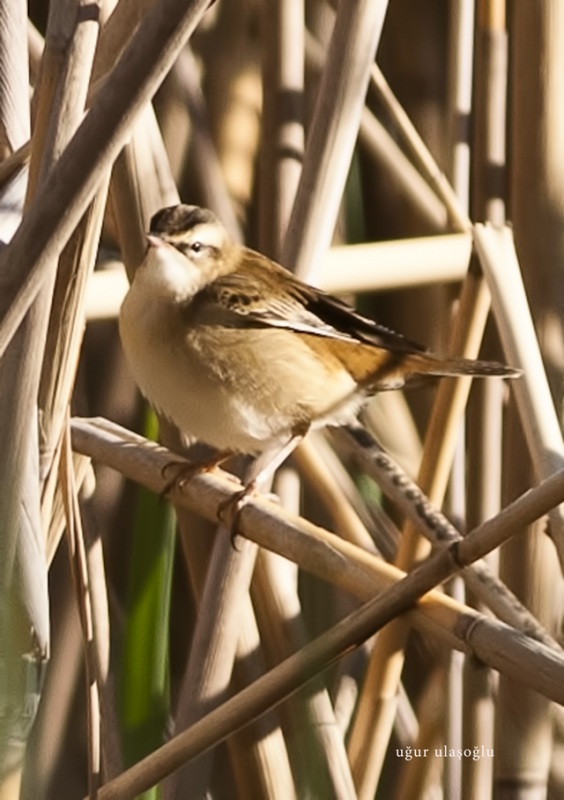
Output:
[[461, 0, 508, 800]]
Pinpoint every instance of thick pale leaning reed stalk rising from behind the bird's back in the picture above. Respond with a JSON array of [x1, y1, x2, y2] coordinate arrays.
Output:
[[282, 0, 388, 280]]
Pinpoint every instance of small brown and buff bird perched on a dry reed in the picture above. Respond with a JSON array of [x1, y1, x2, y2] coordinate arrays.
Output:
[[119, 204, 518, 524]]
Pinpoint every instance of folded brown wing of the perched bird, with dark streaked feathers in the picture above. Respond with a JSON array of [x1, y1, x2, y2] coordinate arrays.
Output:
[[186, 250, 424, 353]]
